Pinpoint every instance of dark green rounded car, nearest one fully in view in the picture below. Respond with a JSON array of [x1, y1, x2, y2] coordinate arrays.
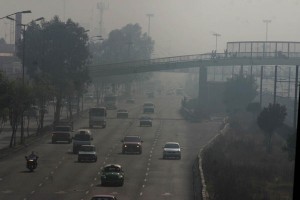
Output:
[[101, 164, 124, 186]]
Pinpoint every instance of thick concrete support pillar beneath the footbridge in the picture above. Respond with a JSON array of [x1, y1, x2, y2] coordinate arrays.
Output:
[[198, 66, 209, 108]]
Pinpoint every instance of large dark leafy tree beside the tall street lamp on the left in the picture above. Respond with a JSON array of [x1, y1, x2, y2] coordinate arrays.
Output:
[[19, 16, 89, 121]]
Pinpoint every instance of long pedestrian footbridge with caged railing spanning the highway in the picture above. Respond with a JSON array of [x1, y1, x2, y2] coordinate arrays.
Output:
[[89, 41, 300, 78]]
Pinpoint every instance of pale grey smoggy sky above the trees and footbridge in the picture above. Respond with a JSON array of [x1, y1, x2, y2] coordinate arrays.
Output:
[[0, 0, 300, 57]]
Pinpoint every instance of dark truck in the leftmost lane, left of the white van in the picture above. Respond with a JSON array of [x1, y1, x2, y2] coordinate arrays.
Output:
[[51, 120, 73, 144]]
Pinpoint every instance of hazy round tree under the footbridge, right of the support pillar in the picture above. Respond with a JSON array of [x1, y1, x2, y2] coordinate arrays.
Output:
[[223, 74, 257, 114]]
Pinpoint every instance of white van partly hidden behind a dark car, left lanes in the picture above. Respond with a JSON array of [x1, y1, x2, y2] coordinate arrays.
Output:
[[73, 129, 93, 153]]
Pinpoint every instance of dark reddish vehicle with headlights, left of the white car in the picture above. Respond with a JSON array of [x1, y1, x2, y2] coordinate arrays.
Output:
[[121, 135, 143, 154]]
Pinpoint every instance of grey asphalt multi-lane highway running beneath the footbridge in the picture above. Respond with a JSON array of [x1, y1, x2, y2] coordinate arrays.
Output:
[[0, 95, 220, 200]]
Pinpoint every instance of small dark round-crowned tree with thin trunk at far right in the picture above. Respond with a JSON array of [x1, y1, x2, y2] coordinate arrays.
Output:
[[257, 103, 287, 153]]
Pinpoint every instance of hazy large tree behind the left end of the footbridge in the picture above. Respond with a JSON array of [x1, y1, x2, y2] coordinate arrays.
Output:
[[91, 24, 154, 95]]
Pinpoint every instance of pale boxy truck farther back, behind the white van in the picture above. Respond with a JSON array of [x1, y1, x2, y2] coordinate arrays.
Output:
[[89, 107, 107, 128]]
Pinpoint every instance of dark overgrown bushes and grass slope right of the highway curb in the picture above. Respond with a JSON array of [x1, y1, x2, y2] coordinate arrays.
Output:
[[202, 122, 294, 200]]
